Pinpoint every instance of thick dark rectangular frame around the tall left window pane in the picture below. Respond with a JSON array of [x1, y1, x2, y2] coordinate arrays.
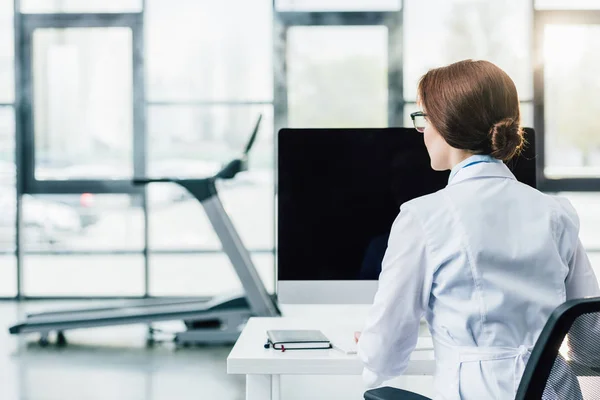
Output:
[[15, 13, 146, 196]]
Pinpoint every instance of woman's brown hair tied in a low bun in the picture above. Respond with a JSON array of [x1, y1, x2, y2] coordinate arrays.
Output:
[[418, 60, 524, 161]]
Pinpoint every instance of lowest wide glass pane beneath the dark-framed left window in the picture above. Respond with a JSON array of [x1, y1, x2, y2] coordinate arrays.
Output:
[[23, 254, 144, 296]]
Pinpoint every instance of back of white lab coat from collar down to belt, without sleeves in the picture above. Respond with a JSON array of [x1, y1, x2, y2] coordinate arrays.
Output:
[[418, 159, 578, 346]]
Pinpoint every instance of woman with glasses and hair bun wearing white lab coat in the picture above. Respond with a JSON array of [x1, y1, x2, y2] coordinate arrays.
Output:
[[358, 60, 600, 400]]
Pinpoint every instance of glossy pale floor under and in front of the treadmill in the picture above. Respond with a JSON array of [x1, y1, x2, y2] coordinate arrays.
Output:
[[0, 301, 245, 400]]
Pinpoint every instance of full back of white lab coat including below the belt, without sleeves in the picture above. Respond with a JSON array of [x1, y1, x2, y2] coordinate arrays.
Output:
[[404, 158, 592, 399]]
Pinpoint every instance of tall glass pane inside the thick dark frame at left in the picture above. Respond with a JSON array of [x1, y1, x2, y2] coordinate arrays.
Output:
[[33, 28, 133, 179]]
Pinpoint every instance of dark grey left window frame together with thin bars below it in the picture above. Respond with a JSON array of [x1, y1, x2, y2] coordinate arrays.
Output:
[[13, 10, 149, 299]]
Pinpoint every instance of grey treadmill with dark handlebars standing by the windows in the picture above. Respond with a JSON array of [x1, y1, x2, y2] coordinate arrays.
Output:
[[9, 115, 281, 346]]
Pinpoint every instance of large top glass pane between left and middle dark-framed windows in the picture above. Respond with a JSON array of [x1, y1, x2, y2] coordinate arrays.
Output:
[[145, 0, 273, 101]]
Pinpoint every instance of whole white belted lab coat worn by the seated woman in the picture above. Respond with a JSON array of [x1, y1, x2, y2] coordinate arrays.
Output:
[[358, 156, 600, 400]]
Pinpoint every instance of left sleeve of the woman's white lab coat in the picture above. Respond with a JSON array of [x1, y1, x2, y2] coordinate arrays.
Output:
[[358, 210, 431, 388]]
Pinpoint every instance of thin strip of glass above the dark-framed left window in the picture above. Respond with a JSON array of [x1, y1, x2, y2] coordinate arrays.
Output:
[[21, 0, 143, 13]]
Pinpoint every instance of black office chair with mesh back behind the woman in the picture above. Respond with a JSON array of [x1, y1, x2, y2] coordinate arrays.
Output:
[[365, 297, 600, 400]]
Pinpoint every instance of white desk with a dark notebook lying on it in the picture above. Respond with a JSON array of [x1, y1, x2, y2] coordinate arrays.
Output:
[[227, 317, 435, 400]]
